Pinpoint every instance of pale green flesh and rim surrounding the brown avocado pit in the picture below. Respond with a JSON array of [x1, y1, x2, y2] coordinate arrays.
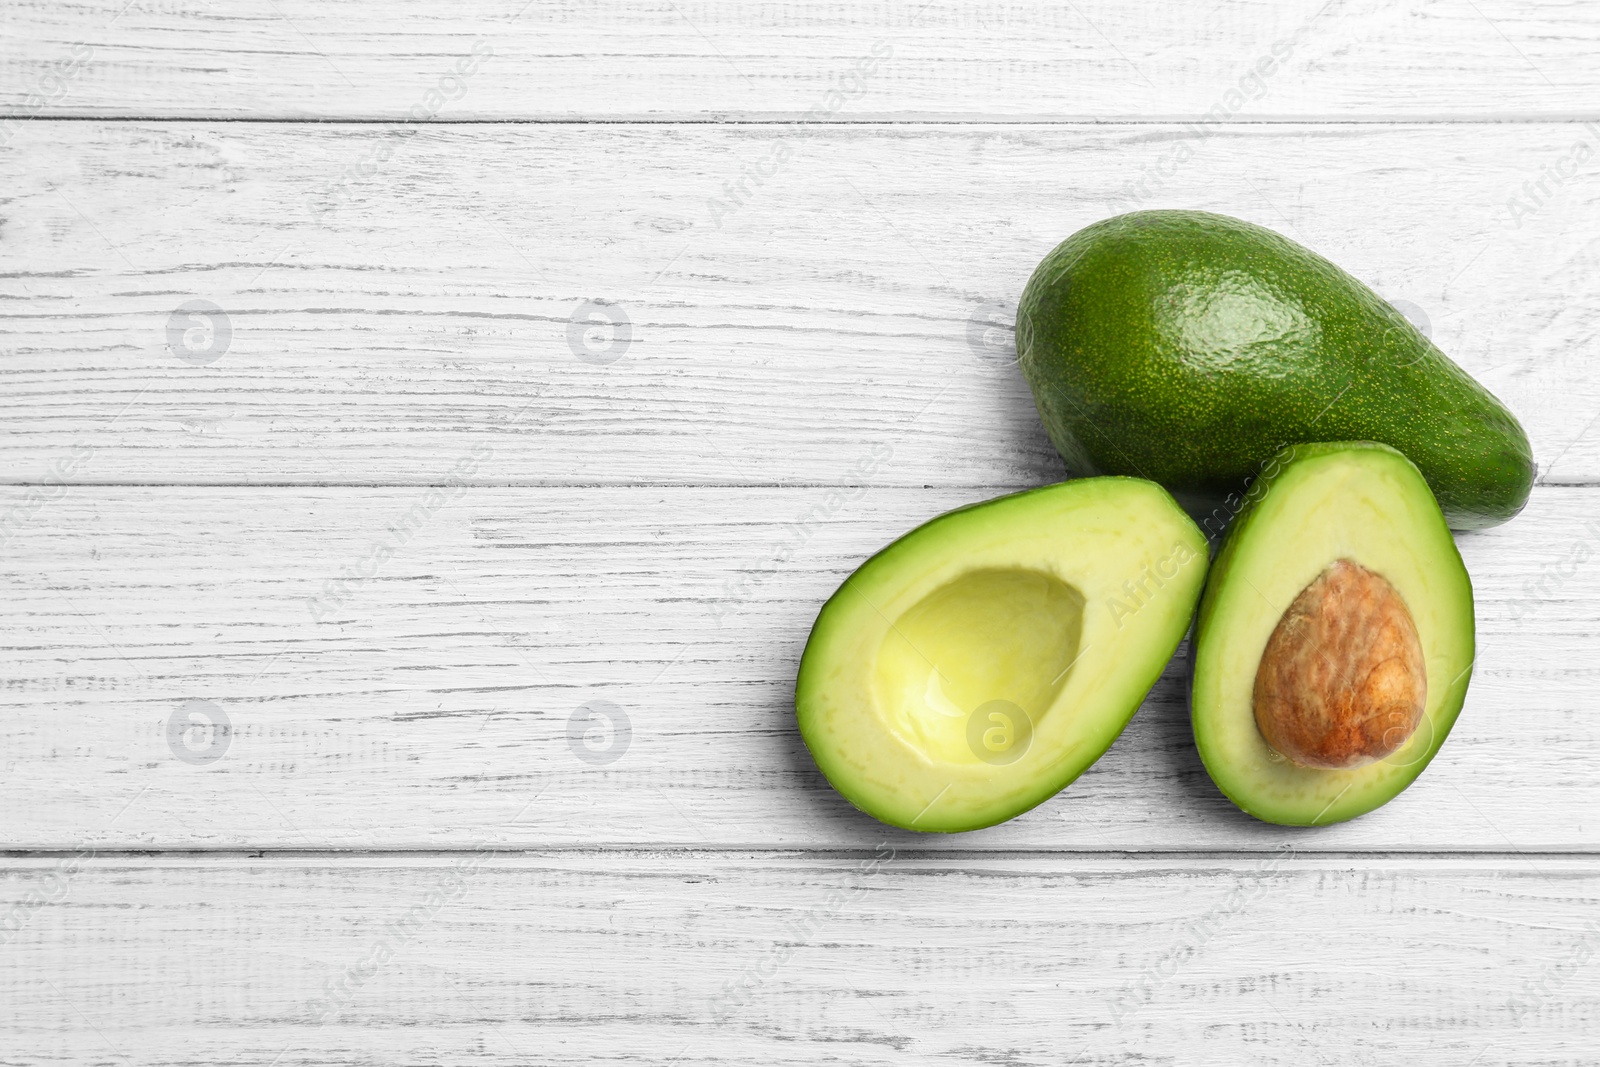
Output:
[[1190, 443, 1474, 825]]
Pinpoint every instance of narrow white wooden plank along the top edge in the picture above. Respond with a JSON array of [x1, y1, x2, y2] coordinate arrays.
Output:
[[0, 0, 1600, 122]]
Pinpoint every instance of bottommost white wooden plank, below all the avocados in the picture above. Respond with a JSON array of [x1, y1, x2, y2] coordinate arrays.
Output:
[[0, 841, 1600, 1067]]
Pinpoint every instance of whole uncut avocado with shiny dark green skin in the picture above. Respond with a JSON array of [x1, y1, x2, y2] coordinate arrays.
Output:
[[1016, 210, 1534, 534]]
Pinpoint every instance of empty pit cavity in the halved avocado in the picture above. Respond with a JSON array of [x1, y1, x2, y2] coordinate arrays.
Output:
[[872, 569, 1085, 765]]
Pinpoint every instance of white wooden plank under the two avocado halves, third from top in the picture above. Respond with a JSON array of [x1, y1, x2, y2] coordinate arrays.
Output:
[[0, 485, 1600, 851]]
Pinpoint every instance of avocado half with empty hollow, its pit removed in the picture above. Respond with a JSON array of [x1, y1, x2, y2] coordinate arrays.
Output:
[[795, 477, 1208, 832]]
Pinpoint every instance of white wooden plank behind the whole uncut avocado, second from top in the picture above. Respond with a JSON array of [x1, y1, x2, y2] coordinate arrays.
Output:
[[0, 119, 1600, 486]]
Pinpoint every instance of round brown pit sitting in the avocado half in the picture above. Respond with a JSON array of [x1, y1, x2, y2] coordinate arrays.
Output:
[[1253, 560, 1427, 769]]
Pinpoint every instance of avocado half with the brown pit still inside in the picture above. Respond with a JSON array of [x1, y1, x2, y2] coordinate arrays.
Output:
[[1189, 442, 1474, 825]]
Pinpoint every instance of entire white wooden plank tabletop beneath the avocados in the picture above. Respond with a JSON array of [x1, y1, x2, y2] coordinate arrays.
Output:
[[0, 0, 1600, 1067]]
